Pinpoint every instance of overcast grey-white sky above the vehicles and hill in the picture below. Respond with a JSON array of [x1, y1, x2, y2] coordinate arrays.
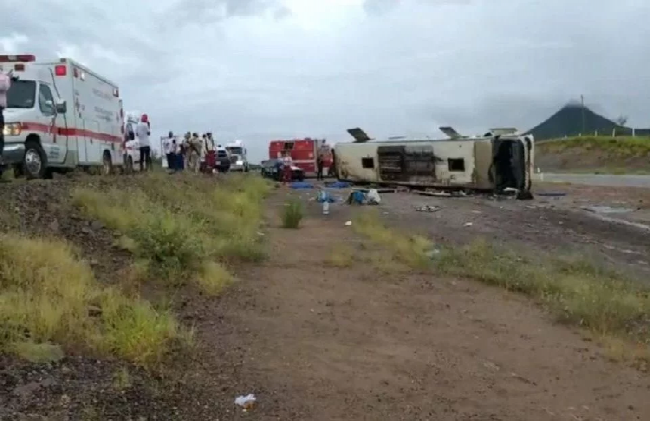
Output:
[[0, 0, 650, 160]]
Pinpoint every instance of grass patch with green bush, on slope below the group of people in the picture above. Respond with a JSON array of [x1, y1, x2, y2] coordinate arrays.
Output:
[[73, 173, 270, 294]]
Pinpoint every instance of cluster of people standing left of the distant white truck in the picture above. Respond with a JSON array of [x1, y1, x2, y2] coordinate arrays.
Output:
[[163, 132, 214, 172]]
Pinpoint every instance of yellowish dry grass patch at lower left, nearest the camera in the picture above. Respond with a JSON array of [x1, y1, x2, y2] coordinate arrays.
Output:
[[0, 236, 184, 366]]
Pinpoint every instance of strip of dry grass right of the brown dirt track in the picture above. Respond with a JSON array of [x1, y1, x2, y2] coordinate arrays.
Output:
[[346, 212, 650, 369]]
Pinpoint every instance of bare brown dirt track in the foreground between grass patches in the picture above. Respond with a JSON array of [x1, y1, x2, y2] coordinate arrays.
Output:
[[197, 189, 650, 420]]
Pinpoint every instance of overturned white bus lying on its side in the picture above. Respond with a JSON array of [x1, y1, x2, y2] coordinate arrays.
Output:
[[334, 127, 534, 199]]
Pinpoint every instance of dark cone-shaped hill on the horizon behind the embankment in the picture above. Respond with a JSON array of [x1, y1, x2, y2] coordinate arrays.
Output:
[[528, 104, 650, 140]]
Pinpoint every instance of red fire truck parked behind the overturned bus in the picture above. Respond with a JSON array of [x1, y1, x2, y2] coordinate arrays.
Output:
[[269, 137, 332, 175]]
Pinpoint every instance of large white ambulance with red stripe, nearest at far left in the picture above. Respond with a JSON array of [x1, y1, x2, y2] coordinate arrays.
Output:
[[0, 55, 124, 178]]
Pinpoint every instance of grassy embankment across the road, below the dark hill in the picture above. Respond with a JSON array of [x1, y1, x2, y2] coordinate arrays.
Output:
[[536, 136, 650, 174]]
